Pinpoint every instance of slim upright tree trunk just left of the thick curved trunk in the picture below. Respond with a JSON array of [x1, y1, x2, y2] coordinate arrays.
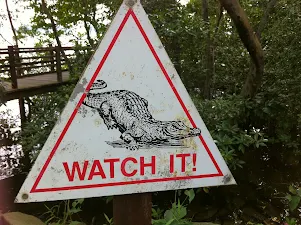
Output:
[[202, 0, 214, 99]]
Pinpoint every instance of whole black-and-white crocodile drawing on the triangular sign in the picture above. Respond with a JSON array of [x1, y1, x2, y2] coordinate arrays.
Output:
[[83, 80, 201, 150]]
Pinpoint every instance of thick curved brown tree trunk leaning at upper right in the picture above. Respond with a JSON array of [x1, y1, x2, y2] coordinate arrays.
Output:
[[219, 0, 264, 98]]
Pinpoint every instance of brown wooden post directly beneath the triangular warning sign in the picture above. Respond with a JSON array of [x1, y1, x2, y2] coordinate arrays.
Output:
[[113, 193, 152, 225]]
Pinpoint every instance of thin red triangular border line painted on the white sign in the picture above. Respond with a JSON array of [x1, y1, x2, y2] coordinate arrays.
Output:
[[30, 9, 223, 193]]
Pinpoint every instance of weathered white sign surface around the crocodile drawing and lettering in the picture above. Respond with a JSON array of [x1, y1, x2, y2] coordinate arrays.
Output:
[[16, 2, 235, 203]]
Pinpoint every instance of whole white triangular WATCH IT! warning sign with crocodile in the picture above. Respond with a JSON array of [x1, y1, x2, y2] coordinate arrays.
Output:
[[16, 2, 235, 203]]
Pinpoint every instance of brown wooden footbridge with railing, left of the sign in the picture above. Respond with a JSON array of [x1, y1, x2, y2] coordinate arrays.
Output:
[[0, 46, 82, 100]]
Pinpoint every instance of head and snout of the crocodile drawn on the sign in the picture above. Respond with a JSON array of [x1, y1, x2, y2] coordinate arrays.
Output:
[[164, 121, 201, 139]]
